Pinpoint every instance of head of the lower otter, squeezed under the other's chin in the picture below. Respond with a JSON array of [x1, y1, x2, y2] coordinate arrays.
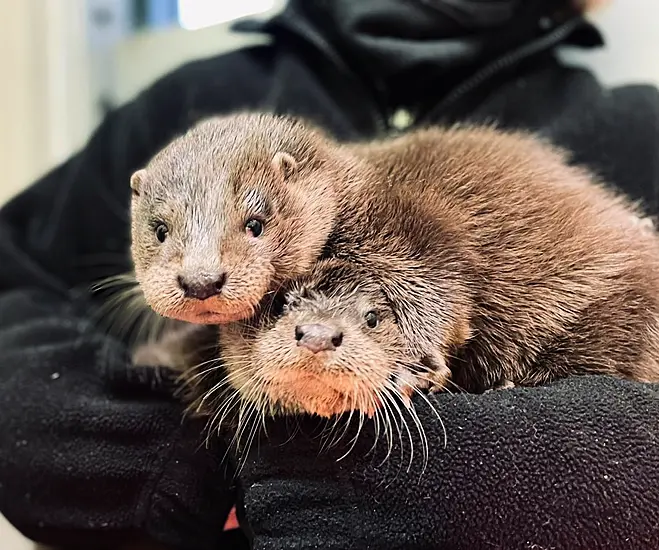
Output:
[[220, 259, 422, 417]]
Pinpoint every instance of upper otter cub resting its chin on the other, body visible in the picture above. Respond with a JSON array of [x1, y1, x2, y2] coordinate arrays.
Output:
[[131, 114, 659, 391]]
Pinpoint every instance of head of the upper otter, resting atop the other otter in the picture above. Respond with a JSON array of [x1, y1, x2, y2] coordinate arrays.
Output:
[[131, 114, 340, 324]]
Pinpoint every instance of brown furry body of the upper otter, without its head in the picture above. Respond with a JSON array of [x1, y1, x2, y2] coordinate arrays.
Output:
[[330, 128, 659, 390]]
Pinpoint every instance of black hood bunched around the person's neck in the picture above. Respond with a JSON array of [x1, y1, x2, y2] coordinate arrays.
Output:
[[234, 0, 603, 106]]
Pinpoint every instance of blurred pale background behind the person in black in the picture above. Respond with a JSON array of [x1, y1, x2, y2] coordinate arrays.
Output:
[[0, 0, 659, 550]]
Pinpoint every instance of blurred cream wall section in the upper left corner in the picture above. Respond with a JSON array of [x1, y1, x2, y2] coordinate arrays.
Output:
[[0, 0, 95, 207]]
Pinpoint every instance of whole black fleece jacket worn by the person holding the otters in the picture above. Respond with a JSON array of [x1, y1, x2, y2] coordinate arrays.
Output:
[[0, 0, 659, 550]]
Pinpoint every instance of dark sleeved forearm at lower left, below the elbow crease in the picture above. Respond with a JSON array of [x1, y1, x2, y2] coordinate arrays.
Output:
[[0, 291, 244, 550]]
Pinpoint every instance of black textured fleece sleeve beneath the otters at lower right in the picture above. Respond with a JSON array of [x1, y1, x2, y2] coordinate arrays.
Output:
[[241, 376, 659, 550]]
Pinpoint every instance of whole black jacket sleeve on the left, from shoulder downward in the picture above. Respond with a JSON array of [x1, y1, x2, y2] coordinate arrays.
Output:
[[0, 48, 268, 549]]
